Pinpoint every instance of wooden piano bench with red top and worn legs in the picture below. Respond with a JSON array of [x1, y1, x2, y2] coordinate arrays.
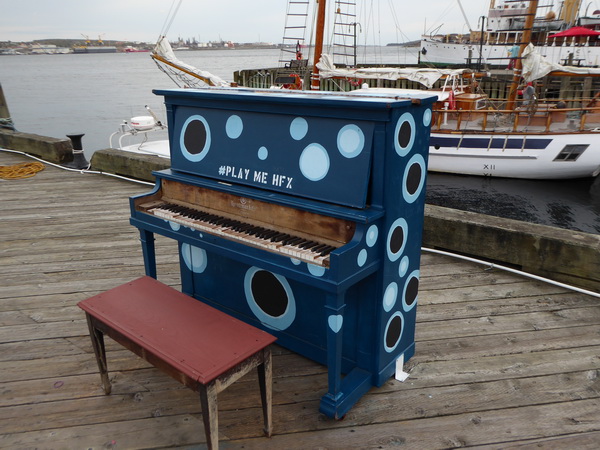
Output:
[[79, 277, 275, 448]]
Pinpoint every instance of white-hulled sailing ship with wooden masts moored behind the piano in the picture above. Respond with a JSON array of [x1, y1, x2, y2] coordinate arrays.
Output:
[[139, 0, 600, 179]]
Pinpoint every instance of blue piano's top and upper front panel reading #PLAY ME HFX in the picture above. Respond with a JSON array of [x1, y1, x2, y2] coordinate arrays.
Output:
[[154, 88, 435, 208]]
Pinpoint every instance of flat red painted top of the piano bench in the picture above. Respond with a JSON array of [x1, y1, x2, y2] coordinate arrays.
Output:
[[79, 276, 276, 384]]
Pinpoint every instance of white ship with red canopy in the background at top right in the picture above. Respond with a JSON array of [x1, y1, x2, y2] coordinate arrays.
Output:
[[419, 0, 600, 67]]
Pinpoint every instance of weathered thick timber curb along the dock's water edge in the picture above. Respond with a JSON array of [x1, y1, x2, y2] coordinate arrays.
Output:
[[0, 130, 600, 292]]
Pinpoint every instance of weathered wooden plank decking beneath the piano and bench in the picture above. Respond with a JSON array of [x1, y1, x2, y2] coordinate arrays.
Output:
[[0, 153, 600, 449]]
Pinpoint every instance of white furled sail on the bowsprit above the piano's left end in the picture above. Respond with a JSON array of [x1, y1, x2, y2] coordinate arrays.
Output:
[[152, 36, 231, 87]]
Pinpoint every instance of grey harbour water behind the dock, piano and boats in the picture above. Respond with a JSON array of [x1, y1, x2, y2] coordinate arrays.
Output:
[[0, 47, 600, 234]]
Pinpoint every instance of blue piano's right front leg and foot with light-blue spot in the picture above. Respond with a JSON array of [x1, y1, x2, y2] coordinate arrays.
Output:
[[319, 293, 371, 419]]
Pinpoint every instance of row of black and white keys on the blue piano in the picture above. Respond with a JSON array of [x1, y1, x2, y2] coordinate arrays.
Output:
[[146, 203, 337, 267]]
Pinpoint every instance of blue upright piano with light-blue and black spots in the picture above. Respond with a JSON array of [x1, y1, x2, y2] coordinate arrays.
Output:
[[131, 88, 436, 418]]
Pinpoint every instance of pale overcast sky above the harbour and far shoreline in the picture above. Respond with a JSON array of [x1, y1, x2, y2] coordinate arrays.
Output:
[[0, 0, 584, 45]]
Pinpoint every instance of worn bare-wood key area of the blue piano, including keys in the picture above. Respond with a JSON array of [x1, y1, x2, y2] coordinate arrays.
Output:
[[135, 179, 356, 267]]
